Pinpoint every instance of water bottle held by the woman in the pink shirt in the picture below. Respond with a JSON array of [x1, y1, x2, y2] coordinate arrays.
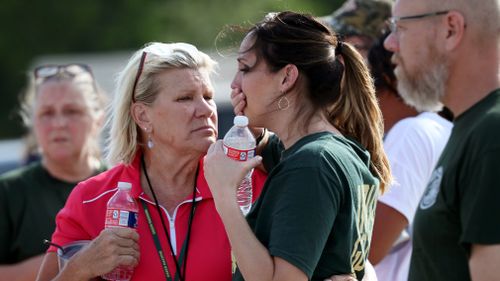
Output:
[[101, 182, 139, 281]]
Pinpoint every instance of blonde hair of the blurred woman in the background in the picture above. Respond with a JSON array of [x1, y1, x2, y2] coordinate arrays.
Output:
[[19, 70, 108, 160]]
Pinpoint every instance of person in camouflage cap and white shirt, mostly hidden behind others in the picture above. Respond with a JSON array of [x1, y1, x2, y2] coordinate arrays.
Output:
[[320, 0, 452, 281]]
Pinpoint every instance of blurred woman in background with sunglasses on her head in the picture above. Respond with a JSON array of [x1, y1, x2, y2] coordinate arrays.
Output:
[[0, 64, 106, 280]]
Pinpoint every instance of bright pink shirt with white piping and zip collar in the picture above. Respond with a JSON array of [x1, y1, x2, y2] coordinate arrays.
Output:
[[48, 153, 266, 281]]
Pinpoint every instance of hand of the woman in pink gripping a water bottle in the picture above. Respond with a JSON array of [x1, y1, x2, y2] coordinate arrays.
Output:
[[64, 227, 140, 279]]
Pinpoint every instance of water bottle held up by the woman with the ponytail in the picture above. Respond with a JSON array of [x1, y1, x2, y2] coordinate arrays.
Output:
[[223, 115, 255, 216]]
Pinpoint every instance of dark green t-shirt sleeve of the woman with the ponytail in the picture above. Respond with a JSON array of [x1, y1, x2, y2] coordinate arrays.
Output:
[[269, 165, 341, 278]]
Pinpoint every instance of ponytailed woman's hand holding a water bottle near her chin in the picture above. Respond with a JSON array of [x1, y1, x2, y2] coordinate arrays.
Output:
[[203, 140, 262, 212]]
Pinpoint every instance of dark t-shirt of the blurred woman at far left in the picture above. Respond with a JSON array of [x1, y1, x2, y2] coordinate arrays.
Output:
[[0, 162, 105, 264]]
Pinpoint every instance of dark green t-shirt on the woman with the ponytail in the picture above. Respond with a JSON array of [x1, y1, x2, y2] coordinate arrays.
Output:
[[233, 132, 378, 280]]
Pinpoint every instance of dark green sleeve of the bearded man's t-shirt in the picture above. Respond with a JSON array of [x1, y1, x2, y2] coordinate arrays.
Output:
[[460, 147, 500, 245]]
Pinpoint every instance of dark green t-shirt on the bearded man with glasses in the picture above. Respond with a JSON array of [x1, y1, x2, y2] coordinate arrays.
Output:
[[409, 90, 500, 281]]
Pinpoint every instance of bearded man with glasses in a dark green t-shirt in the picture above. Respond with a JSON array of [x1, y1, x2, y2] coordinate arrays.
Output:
[[385, 0, 500, 281]]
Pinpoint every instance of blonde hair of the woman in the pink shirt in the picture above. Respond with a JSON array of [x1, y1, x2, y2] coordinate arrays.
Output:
[[106, 42, 216, 164]]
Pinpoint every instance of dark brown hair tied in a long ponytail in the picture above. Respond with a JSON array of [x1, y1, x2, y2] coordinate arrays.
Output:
[[247, 12, 391, 191]]
